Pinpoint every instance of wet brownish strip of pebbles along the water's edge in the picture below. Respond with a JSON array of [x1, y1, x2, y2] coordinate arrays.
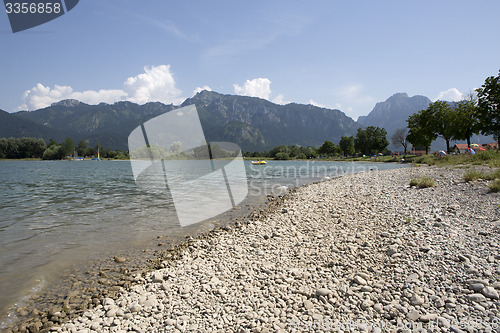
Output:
[[0, 185, 276, 332]]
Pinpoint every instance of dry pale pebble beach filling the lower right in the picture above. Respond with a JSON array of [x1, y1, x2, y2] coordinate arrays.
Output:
[[8, 167, 500, 332]]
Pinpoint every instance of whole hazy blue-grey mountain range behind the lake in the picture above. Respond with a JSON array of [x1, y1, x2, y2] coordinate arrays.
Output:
[[0, 90, 492, 151]]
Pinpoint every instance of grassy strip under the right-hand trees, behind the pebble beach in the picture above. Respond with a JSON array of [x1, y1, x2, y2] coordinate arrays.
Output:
[[409, 150, 500, 167]]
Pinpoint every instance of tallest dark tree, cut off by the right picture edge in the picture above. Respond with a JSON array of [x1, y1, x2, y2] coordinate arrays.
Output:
[[476, 71, 500, 144]]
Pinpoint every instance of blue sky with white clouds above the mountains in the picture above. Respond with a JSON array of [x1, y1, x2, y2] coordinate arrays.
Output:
[[0, 0, 500, 119]]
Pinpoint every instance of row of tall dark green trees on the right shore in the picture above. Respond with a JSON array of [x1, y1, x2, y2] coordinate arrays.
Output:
[[406, 71, 500, 153]]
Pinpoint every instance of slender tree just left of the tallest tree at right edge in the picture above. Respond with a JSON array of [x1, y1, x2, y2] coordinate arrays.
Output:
[[453, 92, 479, 147]]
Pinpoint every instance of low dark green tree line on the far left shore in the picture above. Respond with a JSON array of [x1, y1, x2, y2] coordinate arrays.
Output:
[[0, 138, 128, 160]]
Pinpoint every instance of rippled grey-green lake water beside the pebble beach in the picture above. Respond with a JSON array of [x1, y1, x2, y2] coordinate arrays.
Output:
[[0, 161, 405, 329]]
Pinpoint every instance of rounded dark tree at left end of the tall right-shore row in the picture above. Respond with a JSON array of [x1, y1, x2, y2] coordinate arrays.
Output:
[[406, 109, 437, 154]]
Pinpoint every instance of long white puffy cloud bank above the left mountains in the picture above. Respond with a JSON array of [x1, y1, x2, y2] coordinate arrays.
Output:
[[18, 65, 184, 110]]
